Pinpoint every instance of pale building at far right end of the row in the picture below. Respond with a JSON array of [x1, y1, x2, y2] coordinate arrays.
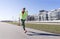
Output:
[[48, 8, 60, 20]]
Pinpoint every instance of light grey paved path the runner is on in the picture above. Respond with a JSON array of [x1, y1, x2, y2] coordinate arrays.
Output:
[[0, 22, 60, 39]]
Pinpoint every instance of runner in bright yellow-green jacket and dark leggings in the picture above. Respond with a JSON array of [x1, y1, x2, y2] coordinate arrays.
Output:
[[20, 8, 28, 33]]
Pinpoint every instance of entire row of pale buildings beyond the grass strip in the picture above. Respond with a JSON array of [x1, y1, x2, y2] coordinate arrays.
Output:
[[27, 8, 60, 21]]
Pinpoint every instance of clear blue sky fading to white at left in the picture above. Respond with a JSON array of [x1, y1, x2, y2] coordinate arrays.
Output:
[[0, 0, 60, 20]]
